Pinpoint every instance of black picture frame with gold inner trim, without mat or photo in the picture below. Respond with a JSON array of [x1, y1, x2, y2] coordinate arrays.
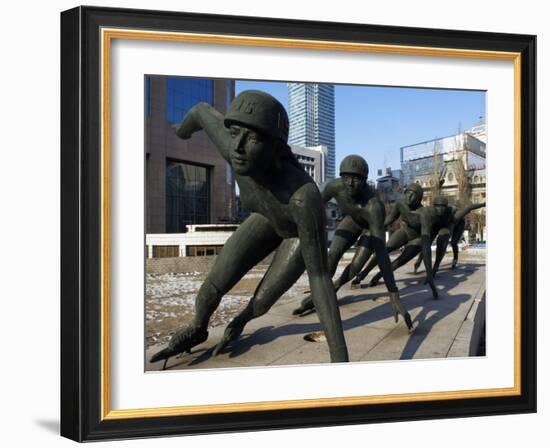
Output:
[[61, 7, 536, 441]]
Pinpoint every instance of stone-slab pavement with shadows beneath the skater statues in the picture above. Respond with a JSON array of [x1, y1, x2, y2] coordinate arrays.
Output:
[[146, 258, 485, 370]]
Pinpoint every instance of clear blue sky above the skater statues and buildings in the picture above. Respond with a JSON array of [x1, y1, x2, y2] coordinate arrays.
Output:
[[235, 81, 485, 178]]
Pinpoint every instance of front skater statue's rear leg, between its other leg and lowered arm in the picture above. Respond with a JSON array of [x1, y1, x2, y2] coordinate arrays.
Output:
[[213, 238, 305, 356]]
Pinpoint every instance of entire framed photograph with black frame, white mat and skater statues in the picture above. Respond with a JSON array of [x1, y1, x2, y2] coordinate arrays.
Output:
[[61, 7, 536, 441]]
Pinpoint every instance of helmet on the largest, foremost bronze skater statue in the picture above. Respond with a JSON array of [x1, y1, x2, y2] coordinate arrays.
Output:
[[224, 90, 288, 143]]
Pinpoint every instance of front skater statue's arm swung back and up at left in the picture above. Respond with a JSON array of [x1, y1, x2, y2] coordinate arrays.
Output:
[[176, 103, 231, 161]]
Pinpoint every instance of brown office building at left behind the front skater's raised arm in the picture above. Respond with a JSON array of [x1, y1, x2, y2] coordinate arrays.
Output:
[[145, 76, 235, 234]]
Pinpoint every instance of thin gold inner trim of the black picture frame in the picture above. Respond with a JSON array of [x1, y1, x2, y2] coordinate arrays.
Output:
[[100, 28, 521, 420]]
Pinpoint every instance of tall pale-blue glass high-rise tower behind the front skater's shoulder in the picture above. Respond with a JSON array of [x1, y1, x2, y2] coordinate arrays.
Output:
[[288, 83, 336, 180]]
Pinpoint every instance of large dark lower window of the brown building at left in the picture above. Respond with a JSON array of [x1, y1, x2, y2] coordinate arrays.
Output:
[[166, 160, 210, 233]]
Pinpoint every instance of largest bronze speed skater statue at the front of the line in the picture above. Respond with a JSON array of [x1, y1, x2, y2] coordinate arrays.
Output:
[[151, 90, 348, 366]]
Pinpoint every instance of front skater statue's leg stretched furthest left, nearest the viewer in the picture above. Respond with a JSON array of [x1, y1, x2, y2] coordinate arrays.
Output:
[[151, 213, 281, 362]]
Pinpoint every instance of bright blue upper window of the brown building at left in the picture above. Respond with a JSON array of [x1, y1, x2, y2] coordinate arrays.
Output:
[[166, 78, 214, 123]]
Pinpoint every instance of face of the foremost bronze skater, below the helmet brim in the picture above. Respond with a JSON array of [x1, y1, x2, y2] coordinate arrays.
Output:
[[229, 125, 279, 176]]
